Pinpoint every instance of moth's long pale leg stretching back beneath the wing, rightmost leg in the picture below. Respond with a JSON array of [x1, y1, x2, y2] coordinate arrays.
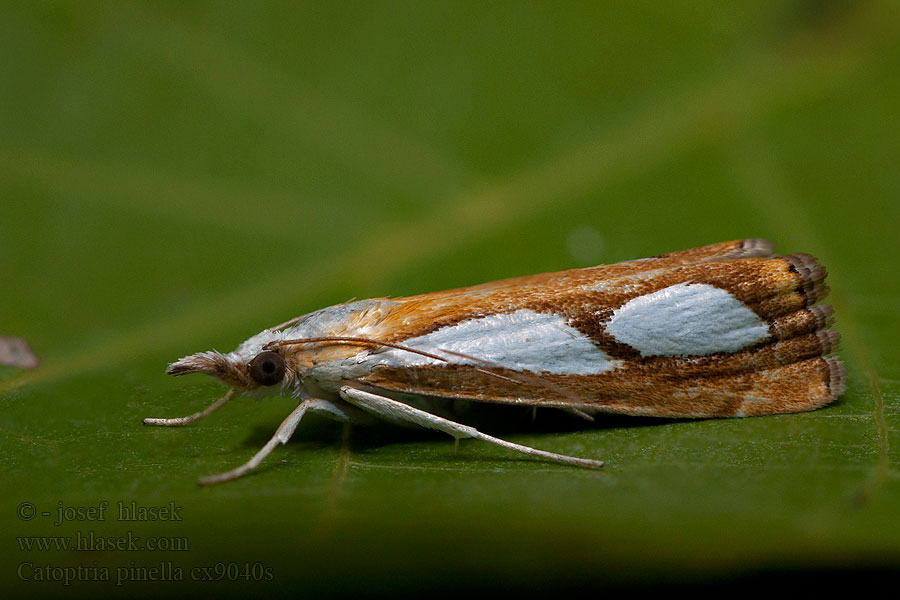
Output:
[[340, 386, 603, 468]]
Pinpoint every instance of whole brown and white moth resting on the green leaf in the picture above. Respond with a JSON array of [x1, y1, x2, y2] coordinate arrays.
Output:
[[144, 239, 845, 484]]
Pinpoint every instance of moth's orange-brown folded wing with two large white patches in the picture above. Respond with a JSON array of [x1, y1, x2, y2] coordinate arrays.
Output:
[[360, 251, 844, 417]]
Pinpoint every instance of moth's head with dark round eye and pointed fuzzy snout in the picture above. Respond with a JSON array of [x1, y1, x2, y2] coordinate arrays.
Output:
[[166, 331, 293, 391]]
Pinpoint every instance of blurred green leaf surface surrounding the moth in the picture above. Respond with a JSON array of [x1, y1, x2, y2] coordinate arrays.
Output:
[[0, 0, 900, 597]]
